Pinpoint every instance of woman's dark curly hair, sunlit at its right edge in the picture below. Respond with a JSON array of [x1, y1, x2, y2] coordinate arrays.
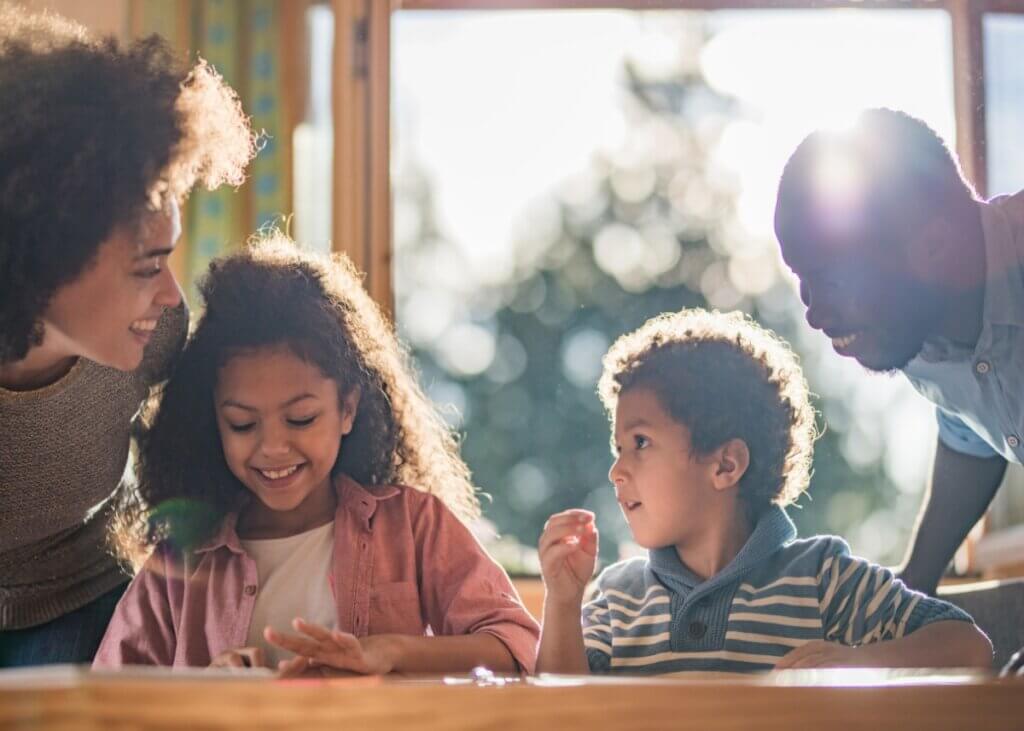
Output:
[[0, 3, 255, 363]]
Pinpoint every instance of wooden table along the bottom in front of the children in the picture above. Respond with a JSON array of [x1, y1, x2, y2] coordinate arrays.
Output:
[[0, 668, 1024, 731]]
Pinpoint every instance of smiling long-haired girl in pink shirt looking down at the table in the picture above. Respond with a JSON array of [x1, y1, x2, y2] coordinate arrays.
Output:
[[95, 234, 539, 674]]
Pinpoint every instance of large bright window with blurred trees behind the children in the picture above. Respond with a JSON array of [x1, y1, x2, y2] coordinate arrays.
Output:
[[319, 0, 1021, 563]]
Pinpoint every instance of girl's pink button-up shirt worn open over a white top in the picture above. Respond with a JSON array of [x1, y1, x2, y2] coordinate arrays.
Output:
[[93, 475, 540, 673]]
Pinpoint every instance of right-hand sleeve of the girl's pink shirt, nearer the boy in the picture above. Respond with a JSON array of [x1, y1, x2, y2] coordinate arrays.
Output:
[[414, 496, 541, 673]]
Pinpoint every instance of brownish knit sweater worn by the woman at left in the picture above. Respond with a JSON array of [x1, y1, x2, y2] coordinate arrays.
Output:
[[0, 304, 187, 631]]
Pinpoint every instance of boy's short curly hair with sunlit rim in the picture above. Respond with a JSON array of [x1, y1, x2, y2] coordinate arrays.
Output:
[[598, 309, 816, 521]]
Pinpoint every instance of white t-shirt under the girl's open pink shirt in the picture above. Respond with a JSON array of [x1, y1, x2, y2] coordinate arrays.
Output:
[[242, 521, 338, 669]]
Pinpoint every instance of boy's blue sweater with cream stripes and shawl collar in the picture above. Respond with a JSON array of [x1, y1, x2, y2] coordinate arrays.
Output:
[[583, 508, 971, 674]]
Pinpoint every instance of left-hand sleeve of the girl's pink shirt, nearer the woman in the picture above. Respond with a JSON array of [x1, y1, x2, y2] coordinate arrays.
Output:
[[92, 548, 176, 669]]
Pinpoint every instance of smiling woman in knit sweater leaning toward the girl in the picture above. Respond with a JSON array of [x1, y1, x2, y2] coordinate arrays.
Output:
[[0, 5, 254, 667]]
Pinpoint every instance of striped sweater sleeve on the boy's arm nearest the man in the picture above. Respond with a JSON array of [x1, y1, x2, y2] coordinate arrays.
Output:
[[818, 539, 973, 646]]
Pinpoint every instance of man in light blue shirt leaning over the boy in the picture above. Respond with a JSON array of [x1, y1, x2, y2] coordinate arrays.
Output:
[[775, 109, 1024, 667]]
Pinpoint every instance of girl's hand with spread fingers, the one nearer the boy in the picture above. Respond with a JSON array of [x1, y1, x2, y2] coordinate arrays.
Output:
[[263, 618, 394, 678]]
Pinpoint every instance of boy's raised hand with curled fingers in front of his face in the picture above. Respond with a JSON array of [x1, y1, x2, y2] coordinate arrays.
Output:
[[539, 510, 597, 604]]
